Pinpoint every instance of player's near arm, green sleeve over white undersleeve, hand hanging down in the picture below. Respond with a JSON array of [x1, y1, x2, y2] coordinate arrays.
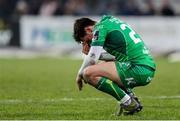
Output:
[[76, 23, 107, 90]]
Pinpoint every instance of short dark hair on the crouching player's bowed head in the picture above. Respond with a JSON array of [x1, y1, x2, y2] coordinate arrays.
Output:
[[73, 18, 96, 43]]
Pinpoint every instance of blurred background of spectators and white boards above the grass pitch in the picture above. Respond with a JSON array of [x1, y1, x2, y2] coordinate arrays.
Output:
[[0, 0, 180, 60]]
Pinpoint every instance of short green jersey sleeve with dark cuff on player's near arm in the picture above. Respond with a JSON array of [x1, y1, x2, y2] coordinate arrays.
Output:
[[91, 25, 107, 46]]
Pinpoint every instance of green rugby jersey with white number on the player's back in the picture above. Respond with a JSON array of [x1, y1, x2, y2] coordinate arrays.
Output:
[[91, 16, 156, 69]]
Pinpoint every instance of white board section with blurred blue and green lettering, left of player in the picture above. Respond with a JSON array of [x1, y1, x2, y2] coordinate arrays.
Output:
[[20, 16, 77, 49]]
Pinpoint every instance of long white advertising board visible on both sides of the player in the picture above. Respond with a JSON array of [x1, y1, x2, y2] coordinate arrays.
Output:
[[20, 16, 180, 53]]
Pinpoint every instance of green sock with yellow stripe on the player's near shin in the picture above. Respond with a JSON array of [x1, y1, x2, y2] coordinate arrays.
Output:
[[96, 77, 127, 101]]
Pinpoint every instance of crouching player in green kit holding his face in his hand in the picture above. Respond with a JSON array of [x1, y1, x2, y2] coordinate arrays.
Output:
[[73, 16, 155, 116]]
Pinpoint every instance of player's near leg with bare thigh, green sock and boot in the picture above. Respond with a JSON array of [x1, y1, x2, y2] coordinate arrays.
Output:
[[83, 62, 139, 115]]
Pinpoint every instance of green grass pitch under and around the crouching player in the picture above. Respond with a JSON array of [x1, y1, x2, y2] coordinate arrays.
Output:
[[0, 58, 180, 120]]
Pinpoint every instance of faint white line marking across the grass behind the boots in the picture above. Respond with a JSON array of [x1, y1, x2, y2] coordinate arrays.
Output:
[[0, 95, 180, 104]]
